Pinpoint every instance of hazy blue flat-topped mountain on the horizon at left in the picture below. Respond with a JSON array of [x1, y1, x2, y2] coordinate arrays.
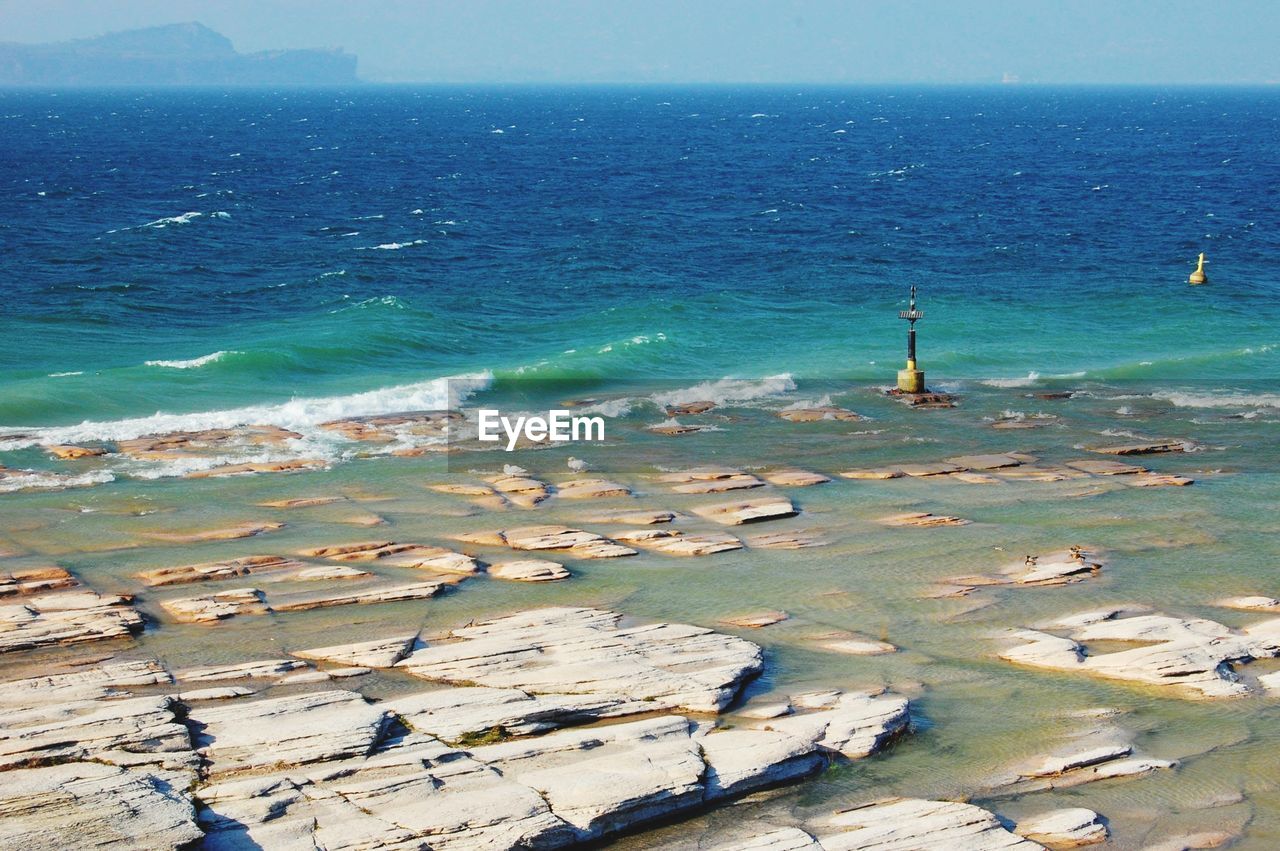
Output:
[[0, 23, 357, 86]]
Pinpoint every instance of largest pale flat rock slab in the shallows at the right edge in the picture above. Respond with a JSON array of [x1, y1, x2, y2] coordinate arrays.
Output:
[[1000, 609, 1280, 697]]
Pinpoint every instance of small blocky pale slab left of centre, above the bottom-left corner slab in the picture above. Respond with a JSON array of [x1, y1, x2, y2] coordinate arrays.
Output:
[[189, 690, 390, 775]]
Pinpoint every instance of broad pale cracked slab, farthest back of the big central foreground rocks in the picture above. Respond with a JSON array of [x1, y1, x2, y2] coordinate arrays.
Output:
[[397, 608, 763, 712]]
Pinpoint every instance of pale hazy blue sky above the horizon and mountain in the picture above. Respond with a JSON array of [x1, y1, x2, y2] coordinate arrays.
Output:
[[0, 0, 1280, 83]]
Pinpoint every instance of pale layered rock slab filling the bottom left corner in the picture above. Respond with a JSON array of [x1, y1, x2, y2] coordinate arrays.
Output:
[[0, 763, 204, 851]]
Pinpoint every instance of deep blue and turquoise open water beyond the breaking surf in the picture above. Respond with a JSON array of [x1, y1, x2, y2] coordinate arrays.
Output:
[[0, 87, 1280, 426]]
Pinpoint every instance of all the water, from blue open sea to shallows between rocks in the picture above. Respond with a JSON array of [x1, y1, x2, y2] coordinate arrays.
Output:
[[0, 87, 1280, 848]]
